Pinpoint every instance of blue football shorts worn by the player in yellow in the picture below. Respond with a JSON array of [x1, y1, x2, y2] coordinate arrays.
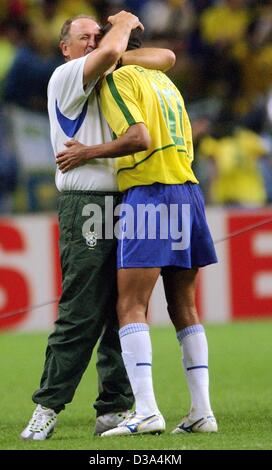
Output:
[[117, 182, 217, 269]]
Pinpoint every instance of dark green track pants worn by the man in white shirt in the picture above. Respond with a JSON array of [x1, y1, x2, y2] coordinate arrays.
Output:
[[32, 191, 133, 416]]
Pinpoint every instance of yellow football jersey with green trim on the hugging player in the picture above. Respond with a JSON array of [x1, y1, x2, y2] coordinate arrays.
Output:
[[100, 65, 198, 191]]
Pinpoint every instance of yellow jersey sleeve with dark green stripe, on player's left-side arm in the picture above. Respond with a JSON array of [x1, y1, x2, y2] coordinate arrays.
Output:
[[100, 67, 145, 137]]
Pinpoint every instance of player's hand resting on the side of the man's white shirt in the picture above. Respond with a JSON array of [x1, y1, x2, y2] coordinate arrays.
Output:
[[56, 140, 88, 173]]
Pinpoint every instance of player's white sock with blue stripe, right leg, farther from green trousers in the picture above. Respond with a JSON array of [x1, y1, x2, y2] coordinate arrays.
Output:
[[177, 325, 212, 419]]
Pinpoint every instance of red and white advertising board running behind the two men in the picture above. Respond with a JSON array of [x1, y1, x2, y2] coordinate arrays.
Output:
[[0, 208, 272, 331]]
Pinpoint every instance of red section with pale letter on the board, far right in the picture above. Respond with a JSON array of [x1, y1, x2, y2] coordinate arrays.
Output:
[[228, 212, 272, 318]]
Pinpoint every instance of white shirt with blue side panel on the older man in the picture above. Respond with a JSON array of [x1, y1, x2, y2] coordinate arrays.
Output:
[[48, 56, 117, 191]]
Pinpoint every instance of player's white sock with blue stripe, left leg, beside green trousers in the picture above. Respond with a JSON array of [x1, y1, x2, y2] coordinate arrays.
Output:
[[119, 323, 159, 416]]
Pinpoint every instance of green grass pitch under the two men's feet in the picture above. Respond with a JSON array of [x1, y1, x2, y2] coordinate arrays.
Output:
[[0, 321, 272, 450]]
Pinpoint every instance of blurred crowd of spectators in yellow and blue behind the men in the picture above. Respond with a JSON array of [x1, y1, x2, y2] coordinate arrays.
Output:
[[0, 0, 272, 214]]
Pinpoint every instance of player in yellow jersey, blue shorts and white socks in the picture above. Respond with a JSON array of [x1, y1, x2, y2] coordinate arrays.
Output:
[[57, 32, 217, 436]]
